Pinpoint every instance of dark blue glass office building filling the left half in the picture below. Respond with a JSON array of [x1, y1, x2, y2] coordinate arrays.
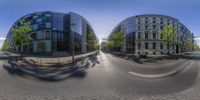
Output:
[[3, 11, 97, 54]]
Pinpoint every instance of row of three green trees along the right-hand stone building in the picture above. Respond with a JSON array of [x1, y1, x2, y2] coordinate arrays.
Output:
[[106, 25, 200, 54]]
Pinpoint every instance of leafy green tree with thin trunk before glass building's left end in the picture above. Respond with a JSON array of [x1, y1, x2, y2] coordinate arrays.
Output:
[[12, 20, 32, 57]]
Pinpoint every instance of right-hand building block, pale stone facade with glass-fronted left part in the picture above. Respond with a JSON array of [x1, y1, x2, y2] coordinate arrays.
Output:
[[108, 14, 193, 55]]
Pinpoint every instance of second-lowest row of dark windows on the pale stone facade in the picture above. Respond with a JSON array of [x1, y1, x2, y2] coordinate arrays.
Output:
[[137, 42, 175, 49]]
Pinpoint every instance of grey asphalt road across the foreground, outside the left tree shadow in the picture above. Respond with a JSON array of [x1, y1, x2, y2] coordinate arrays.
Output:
[[0, 52, 200, 100]]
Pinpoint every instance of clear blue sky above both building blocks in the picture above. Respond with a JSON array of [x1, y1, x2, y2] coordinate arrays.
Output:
[[0, 0, 200, 47]]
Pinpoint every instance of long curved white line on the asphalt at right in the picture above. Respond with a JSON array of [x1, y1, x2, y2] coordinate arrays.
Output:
[[128, 62, 193, 78]]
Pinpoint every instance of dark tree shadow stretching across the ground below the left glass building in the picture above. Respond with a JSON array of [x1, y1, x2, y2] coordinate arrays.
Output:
[[3, 54, 99, 81]]
